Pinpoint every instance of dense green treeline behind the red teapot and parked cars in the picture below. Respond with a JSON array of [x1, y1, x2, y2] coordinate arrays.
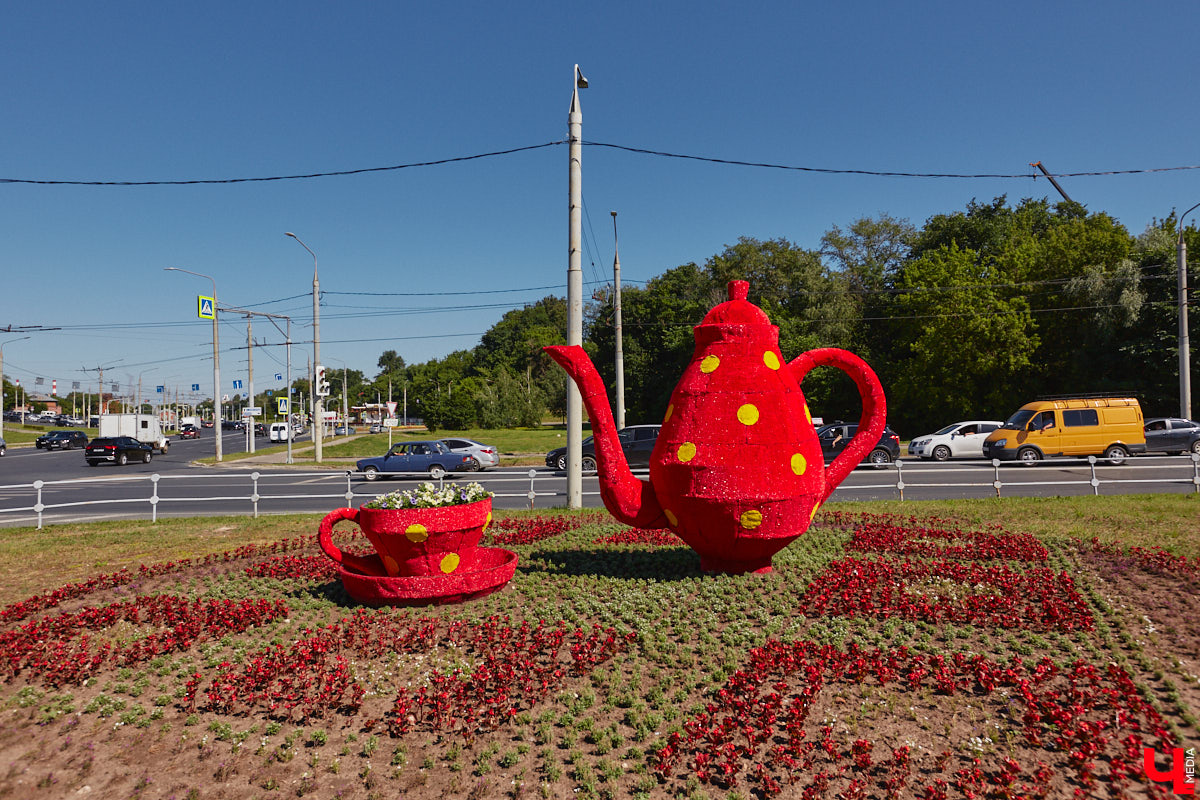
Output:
[[272, 197, 1200, 437]]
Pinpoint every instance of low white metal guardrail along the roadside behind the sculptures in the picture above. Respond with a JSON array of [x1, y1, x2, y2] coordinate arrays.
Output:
[[0, 453, 1200, 529]]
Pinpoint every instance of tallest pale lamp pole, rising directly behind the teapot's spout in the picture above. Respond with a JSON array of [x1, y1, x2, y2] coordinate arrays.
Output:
[[566, 64, 588, 509]]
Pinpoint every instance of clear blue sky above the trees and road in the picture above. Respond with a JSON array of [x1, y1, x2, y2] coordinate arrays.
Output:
[[0, 0, 1200, 407]]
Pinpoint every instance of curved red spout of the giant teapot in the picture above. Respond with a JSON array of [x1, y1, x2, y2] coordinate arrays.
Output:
[[542, 344, 667, 528]]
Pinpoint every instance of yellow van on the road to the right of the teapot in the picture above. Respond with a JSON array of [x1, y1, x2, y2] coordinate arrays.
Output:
[[983, 396, 1146, 464]]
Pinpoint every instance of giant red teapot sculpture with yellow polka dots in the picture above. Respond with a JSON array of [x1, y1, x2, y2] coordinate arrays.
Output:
[[545, 281, 887, 573]]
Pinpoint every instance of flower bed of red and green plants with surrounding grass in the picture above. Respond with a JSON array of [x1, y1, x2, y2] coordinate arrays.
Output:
[[0, 495, 1200, 800]]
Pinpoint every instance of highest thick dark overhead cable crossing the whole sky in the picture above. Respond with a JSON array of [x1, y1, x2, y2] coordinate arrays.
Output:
[[0, 139, 1200, 186]]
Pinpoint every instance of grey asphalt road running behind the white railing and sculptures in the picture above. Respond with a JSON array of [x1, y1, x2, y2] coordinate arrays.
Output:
[[0, 431, 1200, 527]]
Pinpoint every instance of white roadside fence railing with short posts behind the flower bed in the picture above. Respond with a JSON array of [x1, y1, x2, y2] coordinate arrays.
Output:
[[0, 453, 1200, 529]]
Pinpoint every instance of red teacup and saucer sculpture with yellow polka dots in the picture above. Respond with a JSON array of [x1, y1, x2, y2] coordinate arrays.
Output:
[[318, 498, 517, 604]]
